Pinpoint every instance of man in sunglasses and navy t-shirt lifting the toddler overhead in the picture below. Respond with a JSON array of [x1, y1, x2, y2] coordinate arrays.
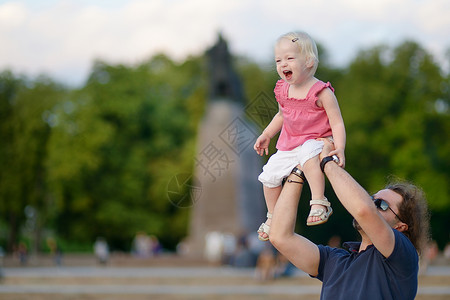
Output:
[[269, 140, 428, 300]]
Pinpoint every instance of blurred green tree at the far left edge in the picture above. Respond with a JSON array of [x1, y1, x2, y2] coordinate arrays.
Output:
[[0, 71, 66, 251]]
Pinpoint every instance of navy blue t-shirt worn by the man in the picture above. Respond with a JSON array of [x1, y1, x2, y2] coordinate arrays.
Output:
[[316, 229, 419, 300]]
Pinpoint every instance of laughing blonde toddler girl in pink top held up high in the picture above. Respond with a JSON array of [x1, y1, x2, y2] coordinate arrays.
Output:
[[254, 32, 346, 241]]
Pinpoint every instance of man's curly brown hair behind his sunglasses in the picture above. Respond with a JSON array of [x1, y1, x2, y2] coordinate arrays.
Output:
[[386, 181, 430, 255]]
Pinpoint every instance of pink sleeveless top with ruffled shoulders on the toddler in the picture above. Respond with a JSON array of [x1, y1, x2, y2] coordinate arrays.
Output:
[[274, 79, 334, 151]]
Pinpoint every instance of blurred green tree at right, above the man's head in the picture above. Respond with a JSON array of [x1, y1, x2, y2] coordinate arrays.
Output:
[[338, 42, 450, 247]]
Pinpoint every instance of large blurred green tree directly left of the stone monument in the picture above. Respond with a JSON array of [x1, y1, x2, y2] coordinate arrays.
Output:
[[44, 55, 204, 250]]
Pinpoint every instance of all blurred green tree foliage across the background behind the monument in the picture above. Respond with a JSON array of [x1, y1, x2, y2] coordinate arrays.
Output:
[[0, 41, 450, 250]]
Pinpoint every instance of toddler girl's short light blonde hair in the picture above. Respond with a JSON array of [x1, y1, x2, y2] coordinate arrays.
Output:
[[277, 31, 319, 76]]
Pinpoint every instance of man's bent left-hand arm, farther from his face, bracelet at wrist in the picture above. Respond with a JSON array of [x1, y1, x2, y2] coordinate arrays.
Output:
[[269, 174, 320, 276]]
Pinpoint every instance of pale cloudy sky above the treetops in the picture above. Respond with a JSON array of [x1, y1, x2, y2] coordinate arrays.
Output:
[[0, 0, 450, 86]]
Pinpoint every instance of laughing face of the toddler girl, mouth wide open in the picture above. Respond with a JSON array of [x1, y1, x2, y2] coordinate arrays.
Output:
[[275, 38, 312, 85]]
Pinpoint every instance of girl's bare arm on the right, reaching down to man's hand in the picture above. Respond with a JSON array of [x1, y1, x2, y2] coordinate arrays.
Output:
[[317, 89, 346, 167]]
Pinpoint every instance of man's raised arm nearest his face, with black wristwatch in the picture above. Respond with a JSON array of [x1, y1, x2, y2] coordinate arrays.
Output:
[[319, 139, 395, 257]]
